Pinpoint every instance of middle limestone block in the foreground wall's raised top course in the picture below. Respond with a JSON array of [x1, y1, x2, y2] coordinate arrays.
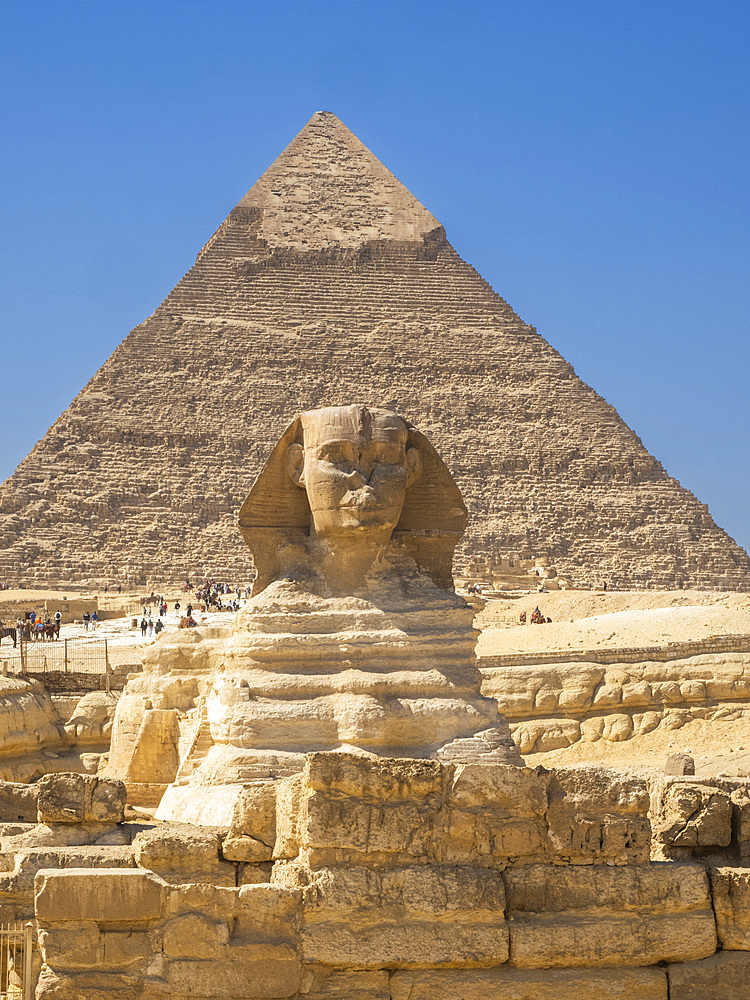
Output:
[[445, 764, 547, 866]]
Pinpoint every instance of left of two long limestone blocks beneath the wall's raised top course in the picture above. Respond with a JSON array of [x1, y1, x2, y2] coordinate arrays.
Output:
[[290, 866, 508, 969]]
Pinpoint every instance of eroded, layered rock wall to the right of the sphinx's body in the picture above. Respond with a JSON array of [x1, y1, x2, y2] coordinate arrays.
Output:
[[478, 636, 750, 754]]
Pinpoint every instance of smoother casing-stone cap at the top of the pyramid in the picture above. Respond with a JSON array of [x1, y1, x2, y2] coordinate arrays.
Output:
[[231, 111, 440, 250]]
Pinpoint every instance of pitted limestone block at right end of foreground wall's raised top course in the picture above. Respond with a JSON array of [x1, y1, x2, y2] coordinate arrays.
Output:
[[547, 765, 651, 864]]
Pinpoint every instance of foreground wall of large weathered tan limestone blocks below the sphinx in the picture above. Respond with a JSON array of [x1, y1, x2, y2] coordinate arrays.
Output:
[[29, 754, 750, 1000]]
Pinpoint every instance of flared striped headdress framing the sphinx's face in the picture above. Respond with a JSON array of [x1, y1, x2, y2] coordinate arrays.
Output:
[[239, 405, 467, 594]]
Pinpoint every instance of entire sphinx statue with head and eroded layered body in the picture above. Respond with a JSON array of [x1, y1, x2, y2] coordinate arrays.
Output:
[[110, 404, 522, 822]]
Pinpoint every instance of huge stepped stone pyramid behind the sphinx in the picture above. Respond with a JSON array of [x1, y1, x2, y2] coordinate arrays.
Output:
[[0, 112, 750, 589]]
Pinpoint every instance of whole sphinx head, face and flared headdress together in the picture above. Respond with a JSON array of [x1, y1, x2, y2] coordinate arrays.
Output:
[[239, 404, 466, 593]]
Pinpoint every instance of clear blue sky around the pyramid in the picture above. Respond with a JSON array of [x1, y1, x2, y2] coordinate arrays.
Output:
[[0, 0, 750, 548]]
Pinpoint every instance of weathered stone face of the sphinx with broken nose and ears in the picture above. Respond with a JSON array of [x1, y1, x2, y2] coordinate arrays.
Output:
[[297, 406, 420, 542]]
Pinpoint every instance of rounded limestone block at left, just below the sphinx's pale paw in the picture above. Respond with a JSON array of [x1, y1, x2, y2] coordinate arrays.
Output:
[[133, 823, 235, 886]]
